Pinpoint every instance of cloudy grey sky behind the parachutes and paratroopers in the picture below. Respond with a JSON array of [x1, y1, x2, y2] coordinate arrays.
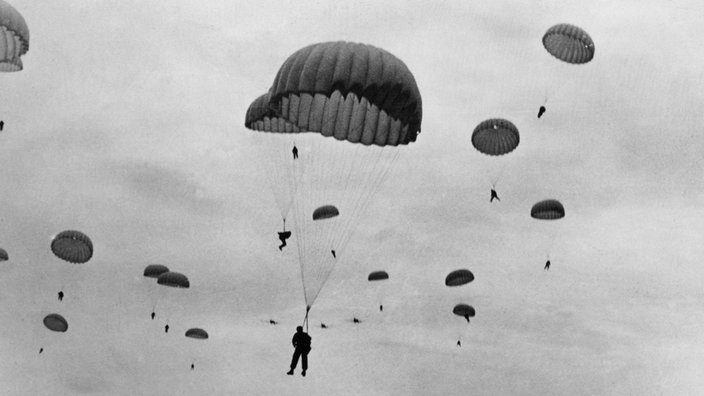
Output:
[[0, 0, 704, 395]]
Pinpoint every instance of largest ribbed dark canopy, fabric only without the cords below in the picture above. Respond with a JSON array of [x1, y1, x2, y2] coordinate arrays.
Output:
[[245, 41, 422, 146]]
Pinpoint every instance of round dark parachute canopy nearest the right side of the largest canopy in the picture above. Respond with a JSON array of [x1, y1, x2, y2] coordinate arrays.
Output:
[[472, 118, 520, 155]]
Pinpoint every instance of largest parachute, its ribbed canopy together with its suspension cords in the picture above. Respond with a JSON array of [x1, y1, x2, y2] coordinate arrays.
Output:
[[245, 41, 422, 307]]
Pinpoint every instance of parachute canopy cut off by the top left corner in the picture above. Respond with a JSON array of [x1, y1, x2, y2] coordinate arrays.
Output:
[[0, 0, 29, 72]]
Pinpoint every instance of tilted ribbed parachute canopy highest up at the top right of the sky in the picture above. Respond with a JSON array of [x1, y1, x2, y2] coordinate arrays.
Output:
[[543, 23, 594, 64]]
